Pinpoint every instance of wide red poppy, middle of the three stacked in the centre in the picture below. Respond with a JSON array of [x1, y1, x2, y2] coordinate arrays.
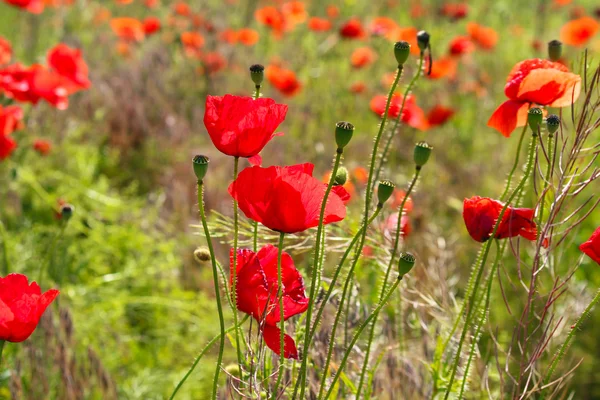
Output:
[[229, 163, 346, 233]]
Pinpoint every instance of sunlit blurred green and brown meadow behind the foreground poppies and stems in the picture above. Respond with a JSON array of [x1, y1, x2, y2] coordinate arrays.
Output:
[[0, 0, 600, 399]]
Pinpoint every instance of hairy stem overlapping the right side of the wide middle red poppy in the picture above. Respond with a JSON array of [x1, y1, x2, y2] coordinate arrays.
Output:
[[298, 148, 344, 398]]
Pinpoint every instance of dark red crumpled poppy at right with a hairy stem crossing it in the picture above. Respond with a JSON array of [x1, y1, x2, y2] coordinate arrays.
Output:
[[463, 196, 537, 242]]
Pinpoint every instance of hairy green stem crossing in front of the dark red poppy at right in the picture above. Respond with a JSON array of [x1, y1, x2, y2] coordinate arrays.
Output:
[[444, 132, 537, 400]]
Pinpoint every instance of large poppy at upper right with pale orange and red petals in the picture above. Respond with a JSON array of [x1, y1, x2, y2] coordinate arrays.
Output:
[[488, 58, 581, 137]]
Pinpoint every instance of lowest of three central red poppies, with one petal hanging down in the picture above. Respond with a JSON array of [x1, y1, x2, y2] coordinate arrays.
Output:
[[229, 245, 309, 359]]
